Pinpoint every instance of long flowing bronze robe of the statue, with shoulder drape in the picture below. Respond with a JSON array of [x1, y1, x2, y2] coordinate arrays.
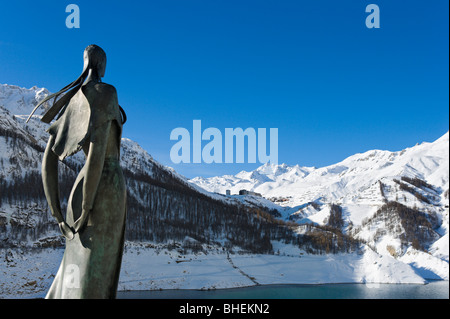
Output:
[[46, 87, 126, 299]]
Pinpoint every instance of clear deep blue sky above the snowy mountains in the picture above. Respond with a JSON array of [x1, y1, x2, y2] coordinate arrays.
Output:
[[0, 0, 449, 177]]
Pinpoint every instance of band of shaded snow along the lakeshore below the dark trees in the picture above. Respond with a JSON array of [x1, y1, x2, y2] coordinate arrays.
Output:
[[0, 243, 425, 298]]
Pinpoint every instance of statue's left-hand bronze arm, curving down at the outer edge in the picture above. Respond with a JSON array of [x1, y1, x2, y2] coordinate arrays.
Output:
[[42, 135, 73, 239]]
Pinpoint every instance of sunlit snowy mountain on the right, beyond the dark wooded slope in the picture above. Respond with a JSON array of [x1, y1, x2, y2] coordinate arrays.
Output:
[[190, 132, 449, 278]]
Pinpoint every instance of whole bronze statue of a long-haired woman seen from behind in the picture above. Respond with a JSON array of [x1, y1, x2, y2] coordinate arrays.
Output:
[[30, 45, 126, 298]]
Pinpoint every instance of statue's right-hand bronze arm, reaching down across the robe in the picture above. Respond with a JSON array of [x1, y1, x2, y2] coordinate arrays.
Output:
[[74, 121, 111, 232]]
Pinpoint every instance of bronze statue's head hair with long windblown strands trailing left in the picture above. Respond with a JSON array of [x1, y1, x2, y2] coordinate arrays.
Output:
[[27, 44, 127, 124]]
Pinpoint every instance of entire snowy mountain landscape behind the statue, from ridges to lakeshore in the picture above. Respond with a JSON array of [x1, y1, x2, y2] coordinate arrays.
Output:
[[0, 84, 449, 298]]
